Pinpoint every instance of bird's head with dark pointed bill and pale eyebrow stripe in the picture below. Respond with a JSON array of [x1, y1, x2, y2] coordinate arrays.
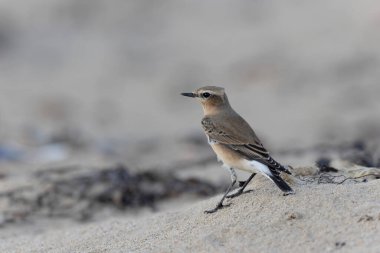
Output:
[[181, 86, 230, 115]]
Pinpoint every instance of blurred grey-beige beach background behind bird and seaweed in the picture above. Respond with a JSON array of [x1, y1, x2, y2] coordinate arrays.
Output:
[[0, 0, 380, 233]]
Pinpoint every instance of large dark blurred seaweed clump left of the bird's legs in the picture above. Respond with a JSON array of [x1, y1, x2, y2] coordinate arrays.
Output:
[[0, 165, 222, 225]]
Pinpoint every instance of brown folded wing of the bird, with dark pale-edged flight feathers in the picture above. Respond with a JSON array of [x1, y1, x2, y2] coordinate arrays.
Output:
[[202, 117, 290, 174]]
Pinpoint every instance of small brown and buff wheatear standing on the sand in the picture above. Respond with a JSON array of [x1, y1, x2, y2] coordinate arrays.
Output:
[[182, 86, 294, 213]]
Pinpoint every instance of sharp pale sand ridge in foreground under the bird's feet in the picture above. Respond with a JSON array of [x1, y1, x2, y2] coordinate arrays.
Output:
[[0, 180, 380, 252]]
